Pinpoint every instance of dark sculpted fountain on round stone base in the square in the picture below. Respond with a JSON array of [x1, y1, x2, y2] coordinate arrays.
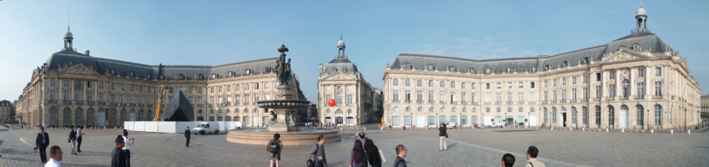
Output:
[[226, 45, 341, 145]]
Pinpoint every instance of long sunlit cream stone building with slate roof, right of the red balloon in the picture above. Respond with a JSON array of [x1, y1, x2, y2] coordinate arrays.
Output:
[[384, 8, 701, 129]]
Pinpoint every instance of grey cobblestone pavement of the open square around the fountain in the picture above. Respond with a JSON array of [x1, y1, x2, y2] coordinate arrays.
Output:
[[0, 129, 709, 167]]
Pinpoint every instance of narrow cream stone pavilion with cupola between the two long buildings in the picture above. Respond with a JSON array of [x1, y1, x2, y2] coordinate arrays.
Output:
[[318, 39, 378, 126]]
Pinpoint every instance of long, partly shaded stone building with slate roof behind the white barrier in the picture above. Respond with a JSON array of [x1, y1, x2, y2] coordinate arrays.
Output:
[[17, 28, 305, 127]]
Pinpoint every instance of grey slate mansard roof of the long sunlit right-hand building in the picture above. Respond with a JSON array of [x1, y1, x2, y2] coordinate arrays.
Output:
[[389, 32, 672, 73]]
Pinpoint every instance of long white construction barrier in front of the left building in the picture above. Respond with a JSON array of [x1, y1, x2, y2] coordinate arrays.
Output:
[[123, 121, 241, 133]]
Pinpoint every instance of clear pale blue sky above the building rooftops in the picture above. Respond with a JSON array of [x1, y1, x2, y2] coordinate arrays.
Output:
[[0, 0, 709, 100]]
